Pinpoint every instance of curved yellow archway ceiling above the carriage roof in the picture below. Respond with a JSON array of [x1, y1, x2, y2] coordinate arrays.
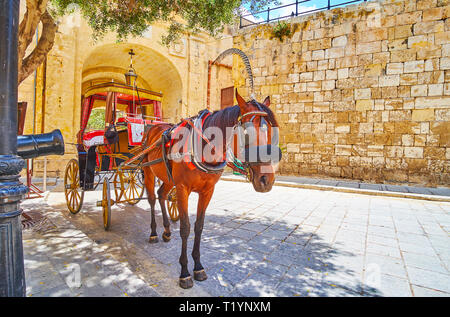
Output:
[[83, 43, 181, 94]]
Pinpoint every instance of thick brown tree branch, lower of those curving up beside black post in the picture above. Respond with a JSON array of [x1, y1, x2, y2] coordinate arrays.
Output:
[[18, 10, 58, 85]]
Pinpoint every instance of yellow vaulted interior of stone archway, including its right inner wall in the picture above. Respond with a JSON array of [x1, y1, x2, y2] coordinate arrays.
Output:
[[81, 43, 182, 122]]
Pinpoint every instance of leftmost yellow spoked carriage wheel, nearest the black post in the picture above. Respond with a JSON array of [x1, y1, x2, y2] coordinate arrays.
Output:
[[64, 159, 84, 214]]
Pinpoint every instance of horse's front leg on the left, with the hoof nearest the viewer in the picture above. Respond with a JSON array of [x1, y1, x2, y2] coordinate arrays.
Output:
[[177, 184, 194, 288]]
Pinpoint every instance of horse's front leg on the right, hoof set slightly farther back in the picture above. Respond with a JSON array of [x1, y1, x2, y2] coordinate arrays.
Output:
[[192, 187, 214, 281]]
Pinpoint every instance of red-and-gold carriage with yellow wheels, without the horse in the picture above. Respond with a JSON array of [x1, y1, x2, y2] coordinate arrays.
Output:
[[64, 82, 178, 230]]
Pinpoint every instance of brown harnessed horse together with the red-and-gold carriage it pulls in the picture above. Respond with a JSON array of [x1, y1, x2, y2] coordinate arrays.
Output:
[[64, 48, 281, 288]]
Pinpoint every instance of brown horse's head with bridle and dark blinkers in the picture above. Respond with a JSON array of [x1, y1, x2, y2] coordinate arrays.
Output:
[[235, 89, 281, 192]]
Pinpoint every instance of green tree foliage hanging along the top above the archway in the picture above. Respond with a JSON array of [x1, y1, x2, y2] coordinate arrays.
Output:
[[50, 0, 279, 45]]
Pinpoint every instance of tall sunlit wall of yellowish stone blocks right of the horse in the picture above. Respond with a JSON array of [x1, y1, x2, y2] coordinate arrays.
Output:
[[233, 0, 450, 186]]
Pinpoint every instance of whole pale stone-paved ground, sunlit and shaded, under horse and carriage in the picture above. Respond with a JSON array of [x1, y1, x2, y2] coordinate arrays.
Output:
[[24, 181, 450, 296]]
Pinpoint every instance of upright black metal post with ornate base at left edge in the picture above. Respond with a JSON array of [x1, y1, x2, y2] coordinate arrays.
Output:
[[0, 0, 28, 297]]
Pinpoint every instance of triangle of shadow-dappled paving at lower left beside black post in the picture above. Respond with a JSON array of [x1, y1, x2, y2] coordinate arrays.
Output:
[[22, 199, 162, 297]]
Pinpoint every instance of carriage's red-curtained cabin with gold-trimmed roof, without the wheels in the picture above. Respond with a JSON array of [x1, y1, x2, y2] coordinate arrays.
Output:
[[77, 82, 162, 189]]
